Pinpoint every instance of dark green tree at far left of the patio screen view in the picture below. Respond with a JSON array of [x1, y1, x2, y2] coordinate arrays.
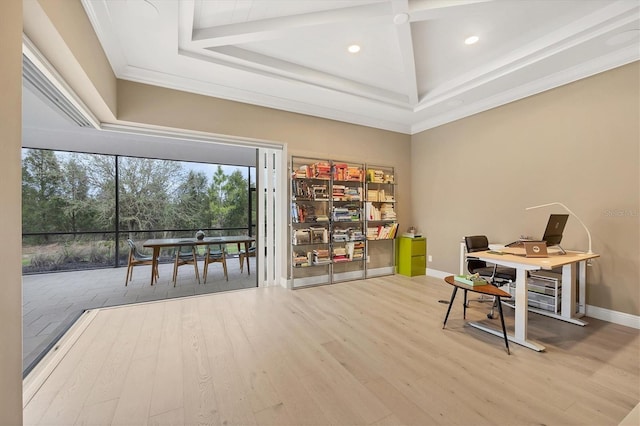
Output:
[[22, 149, 64, 235]]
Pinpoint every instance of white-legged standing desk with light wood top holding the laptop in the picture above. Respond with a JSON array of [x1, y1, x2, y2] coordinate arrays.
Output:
[[467, 251, 600, 351]]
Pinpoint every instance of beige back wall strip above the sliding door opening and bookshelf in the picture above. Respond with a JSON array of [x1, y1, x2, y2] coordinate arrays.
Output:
[[118, 80, 411, 223]]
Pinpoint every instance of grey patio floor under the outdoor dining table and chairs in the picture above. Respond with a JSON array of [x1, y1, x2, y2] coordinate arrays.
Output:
[[22, 257, 257, 371]]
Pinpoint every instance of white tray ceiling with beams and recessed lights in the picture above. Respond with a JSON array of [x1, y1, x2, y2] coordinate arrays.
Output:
[[82, 0, 640, 134]]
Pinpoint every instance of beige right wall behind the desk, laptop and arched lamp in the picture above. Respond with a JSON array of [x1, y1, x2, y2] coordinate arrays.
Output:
[[411, 62, 640, 315]]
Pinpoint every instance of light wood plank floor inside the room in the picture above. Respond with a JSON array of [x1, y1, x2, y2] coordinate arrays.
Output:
[[24, 276, 640, 425]]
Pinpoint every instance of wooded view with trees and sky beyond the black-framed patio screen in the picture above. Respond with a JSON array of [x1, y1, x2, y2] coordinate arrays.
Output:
[[22, 148, 256, 273]]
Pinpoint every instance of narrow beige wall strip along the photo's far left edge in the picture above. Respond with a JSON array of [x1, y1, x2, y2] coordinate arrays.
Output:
[[0, 0, 22, 425]]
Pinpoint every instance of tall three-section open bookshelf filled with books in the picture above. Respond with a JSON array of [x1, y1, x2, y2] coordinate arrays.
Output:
[[289, 156, 397, 288]]
